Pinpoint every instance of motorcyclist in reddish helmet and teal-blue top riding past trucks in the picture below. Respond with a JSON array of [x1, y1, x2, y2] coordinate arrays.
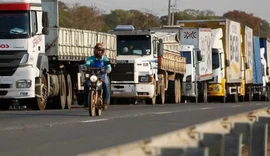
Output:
[[84, 43, 112, 108]]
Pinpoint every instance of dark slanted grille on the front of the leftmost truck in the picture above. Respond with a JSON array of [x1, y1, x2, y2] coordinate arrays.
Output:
[[0, 51, 27, 76]]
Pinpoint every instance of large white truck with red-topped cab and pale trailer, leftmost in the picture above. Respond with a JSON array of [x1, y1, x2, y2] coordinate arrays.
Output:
[[0, 0, 116, 110]]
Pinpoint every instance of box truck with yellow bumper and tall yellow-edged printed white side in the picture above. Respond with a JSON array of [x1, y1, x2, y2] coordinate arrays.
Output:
[[177, 19, 245, 102]]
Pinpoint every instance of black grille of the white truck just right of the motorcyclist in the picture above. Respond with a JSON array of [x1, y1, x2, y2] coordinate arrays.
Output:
[[111, 63, 134, 81]]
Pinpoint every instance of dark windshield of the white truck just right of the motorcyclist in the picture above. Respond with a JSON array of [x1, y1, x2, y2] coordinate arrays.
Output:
[[117, 35, 151, 55]]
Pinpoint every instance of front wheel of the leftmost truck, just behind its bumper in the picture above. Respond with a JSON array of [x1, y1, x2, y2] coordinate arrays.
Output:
[[36, 74, 48, 110]]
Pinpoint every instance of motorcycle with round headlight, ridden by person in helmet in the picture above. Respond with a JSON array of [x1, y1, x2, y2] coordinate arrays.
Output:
[[83, 60, 110, 116]]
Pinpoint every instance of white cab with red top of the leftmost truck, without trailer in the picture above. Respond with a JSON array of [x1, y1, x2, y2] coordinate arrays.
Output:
[[0, 0, 48, 109]]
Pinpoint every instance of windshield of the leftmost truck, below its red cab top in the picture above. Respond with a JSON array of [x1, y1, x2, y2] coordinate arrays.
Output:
[[0, 11, 30, 39]]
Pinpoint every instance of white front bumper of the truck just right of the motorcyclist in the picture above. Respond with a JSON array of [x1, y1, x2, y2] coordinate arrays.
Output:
[[111, 84, 155, 98]]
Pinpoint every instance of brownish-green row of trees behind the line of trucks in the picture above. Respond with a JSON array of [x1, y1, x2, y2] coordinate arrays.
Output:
[[59, 2, 270, 37]]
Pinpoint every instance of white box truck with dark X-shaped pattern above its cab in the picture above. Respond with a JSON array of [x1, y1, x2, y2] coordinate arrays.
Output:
[[152, 25, 213, 103]]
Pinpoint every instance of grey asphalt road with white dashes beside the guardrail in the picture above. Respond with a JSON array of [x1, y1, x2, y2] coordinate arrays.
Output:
[[0, 102, 269, 156]]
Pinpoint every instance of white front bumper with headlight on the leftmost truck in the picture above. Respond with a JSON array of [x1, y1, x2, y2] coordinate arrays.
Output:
[[0, 66, 37, 99]]
